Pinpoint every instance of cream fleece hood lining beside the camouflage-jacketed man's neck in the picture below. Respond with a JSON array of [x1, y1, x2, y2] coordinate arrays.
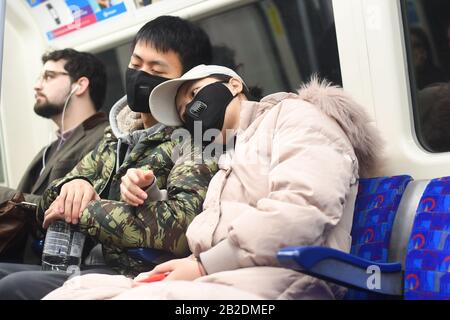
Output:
[[109, 95, 144, 139]]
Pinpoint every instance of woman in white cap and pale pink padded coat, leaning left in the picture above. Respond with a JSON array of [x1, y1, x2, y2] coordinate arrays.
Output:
[[44, 65, 382, 299]]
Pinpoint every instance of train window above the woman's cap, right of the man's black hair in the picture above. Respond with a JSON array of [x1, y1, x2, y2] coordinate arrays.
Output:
[[198, 0, 342, 97]]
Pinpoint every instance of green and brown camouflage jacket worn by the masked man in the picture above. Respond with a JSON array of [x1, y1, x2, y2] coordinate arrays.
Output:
[[37, 97, 217, 270]]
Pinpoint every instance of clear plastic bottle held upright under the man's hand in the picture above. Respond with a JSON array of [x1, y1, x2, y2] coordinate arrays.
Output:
[[42, 220, 85, 271]]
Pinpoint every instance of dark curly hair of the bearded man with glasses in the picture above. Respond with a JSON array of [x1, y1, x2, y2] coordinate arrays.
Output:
[[42, 49, 107, 110]]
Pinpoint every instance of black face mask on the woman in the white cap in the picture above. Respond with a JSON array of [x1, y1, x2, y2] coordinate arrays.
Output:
[[185, 82, 235, 136]]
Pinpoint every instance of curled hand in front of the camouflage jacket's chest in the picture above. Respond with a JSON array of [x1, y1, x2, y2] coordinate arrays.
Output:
[[120, 169, 155, 207]]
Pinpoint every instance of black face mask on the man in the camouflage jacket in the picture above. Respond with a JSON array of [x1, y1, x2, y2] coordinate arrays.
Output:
[[125, 68, 169, 113]]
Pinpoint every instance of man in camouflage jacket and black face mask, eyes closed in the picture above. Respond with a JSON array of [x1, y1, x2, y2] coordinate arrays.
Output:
[[0, 16, 217, 299]]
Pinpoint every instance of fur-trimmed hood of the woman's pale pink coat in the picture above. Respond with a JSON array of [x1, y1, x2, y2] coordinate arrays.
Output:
[[259, 77, 383, 177]]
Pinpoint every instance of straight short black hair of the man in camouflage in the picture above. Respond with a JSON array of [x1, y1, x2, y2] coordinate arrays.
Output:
[[131, 16, 212, 73]]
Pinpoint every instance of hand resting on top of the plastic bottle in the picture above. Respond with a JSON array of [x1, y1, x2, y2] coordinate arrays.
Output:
[[43, 179, 100, 228]]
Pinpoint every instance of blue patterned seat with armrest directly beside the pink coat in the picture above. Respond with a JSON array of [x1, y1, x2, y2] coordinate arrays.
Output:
[[277, 175, 414, 299]]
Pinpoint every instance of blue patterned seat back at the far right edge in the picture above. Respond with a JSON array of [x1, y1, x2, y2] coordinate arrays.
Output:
[[405, 177, 450, 300]]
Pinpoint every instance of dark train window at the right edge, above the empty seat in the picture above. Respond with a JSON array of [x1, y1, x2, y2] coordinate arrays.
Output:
[[402, 0, 450, 153]]
